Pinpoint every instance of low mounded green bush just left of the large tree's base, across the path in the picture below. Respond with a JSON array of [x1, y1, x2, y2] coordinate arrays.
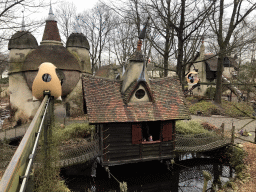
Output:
[[189, 101, 220, 115]]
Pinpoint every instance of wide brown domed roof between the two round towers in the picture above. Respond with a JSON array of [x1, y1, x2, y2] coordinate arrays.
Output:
[[22, 45, 81, 71]]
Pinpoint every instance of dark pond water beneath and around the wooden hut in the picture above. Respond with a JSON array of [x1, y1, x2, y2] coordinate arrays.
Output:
[[62, 158, 234, 192]]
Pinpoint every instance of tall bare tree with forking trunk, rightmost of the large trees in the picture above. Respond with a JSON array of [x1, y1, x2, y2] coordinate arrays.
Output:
[[210, 0, 256, 103]]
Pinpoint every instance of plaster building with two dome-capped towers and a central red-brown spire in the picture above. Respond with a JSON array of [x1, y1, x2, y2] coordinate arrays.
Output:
[[8, 4, 91, 120]]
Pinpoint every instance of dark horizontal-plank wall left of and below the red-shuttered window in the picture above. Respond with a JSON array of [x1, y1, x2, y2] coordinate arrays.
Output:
[[100, 123, 175, 166]]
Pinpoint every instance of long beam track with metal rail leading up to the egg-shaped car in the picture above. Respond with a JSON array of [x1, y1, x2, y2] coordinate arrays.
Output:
[[0, 92, 54, 192]]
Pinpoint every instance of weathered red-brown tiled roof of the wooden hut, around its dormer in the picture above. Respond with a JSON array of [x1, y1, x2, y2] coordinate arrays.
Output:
[[82, 75, 189, 123]]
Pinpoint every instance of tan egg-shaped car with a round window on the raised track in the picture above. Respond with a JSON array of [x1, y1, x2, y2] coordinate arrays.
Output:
[[32, 62, 62, 100]]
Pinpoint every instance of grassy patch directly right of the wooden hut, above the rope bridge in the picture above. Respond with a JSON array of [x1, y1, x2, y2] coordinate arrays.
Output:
[[176, 120, 213, 135]]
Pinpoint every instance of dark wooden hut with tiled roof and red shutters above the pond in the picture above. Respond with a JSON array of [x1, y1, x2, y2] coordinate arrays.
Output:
[[83, 40, 189, 167]]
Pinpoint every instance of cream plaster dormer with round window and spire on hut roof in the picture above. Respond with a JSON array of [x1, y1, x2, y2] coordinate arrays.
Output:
[[121, 40, 153, 104]]
